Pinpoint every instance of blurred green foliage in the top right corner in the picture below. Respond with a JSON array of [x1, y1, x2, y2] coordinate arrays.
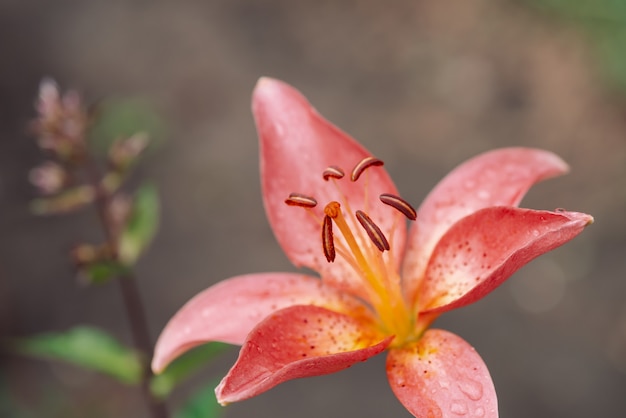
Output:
[[525, 0, 626, 94]]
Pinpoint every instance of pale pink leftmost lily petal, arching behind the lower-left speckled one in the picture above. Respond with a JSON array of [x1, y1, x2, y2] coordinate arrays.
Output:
[[152, 273, 369, 372]]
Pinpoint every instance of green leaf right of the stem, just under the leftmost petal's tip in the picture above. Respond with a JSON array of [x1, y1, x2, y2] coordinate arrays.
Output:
[[150, 342, 231, 399]]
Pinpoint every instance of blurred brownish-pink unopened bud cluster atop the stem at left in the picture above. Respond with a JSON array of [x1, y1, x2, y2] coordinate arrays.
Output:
[[29, 79, 149, 282]]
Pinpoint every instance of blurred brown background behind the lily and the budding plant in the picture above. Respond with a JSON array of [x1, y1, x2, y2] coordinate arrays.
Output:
[[0, 0, 626, 418]]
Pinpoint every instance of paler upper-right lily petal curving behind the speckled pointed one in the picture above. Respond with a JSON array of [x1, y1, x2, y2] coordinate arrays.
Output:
[[404, 148, 568, 301]]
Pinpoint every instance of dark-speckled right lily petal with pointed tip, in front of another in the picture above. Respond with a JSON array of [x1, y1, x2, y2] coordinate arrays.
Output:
[[420, 207, 593, 313]]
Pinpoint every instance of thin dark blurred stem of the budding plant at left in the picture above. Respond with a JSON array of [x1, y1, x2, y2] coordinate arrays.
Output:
[[85, 150, 169, 418]]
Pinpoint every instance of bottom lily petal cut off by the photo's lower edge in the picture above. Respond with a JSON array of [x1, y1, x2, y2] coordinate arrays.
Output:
[[387, 329, 498, 418]]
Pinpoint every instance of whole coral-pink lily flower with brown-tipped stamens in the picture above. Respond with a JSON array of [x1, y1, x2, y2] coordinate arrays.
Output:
[[152, 78, 593, 417]]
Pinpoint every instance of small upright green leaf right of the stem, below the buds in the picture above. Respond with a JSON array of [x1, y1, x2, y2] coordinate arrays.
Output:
[[119, 184, 159, 265]]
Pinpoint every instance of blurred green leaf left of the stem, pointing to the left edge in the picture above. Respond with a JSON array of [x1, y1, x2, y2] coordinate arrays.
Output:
[[13, 326, 143, 384]]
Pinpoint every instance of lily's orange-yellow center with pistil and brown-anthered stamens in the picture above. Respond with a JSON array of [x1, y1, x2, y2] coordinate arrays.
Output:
[[285, 157, 416, 346]]
